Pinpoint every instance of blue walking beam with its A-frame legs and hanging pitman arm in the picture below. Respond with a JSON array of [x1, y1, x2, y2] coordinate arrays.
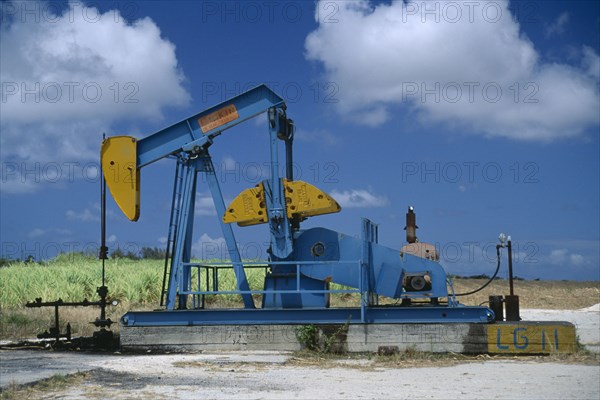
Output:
[[142, 85, 292, 310]]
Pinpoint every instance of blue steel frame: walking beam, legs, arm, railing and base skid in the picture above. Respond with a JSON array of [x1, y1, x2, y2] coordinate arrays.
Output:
[[122, 85, 494, 326]]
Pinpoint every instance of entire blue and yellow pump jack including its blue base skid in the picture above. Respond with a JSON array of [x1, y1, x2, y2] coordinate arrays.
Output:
[[101, 85, 494, 326]]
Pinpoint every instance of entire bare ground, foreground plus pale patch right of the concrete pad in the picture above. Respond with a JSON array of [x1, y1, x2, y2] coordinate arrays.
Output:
[[0, 305, 600, 400]]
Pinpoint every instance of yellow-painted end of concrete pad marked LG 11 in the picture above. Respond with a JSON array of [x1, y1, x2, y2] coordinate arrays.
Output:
[[487, 322, 577, 354]]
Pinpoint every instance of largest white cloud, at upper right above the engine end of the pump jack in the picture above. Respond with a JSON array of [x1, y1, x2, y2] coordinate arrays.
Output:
[[305, 0, 600, 141]]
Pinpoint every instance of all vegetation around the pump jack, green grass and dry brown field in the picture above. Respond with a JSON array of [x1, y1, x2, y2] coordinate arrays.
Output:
[[0, 248, 600, 340]]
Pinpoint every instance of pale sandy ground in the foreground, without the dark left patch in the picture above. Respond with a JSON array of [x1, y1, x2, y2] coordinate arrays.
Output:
[[2, 353, 600, 400]]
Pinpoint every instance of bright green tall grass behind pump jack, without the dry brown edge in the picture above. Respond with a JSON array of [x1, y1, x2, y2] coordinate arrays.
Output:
[[0, 254, 264, 309]]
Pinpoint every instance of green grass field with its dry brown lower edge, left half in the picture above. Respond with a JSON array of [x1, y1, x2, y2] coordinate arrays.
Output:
[[0, 253, 265, 339]]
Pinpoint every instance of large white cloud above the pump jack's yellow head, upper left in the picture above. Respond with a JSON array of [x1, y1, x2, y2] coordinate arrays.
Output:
[[0, 2, 189, 193]]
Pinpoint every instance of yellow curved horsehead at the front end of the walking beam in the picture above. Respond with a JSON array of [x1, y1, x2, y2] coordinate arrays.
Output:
[[100, 136, 140, 221]]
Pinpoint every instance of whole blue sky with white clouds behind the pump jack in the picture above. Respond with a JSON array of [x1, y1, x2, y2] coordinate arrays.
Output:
[[0, 1, 600, 280]]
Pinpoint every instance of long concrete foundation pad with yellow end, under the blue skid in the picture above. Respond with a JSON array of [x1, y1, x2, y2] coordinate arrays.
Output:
[[121, 321, 577, 354]]
